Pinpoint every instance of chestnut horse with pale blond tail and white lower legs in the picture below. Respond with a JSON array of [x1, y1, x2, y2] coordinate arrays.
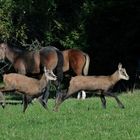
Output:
[[62, 49, 90, 99]]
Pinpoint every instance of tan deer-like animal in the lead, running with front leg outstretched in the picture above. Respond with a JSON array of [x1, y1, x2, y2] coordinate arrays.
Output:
[[54, 64, 129, 111]]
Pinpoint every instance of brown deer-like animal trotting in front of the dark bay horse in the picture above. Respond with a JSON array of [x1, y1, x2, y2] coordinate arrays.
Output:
[[0, 68, 56, 112]]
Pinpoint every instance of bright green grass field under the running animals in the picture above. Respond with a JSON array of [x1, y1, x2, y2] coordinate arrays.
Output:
[[0, 91, 140, 140]]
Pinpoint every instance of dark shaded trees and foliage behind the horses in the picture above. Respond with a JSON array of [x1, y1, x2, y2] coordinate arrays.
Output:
[[0, 0, 140, 89]]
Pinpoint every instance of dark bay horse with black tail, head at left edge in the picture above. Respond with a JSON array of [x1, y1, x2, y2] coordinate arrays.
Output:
[[0, 43, 63, 106]]
